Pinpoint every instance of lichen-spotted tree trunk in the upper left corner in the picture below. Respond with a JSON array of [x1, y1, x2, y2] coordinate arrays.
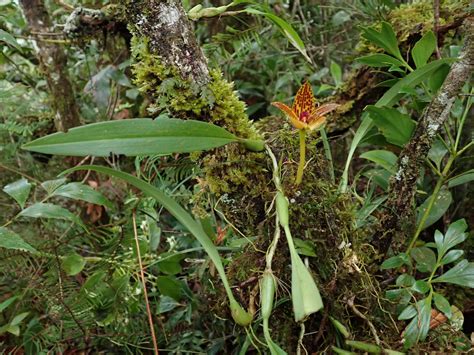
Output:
[[20, 0, 80, 131]]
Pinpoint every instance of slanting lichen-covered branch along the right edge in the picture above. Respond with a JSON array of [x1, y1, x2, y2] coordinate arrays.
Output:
[[377, 17, 474, 253]]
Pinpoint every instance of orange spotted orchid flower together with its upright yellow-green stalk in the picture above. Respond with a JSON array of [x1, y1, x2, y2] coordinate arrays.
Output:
[[272, 81, 339, 185]]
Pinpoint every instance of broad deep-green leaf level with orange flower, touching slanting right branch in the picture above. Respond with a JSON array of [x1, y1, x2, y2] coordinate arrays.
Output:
[[367, 106, 416, 147]]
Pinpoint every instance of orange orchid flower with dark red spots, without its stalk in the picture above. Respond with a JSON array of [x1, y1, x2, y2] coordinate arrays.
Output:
[[272, 81, 339, 131]]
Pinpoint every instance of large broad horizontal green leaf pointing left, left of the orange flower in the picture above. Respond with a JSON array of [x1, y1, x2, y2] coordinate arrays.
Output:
[[23, 118, 238, 157]]
